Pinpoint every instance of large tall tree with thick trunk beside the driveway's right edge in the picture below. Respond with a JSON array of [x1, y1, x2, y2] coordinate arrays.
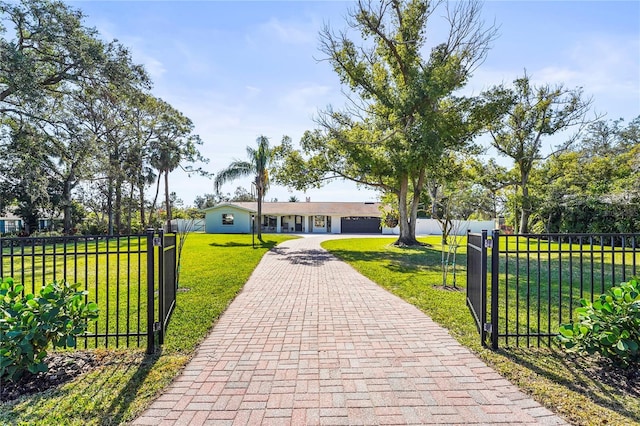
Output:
[[277, 0, 496, 245]]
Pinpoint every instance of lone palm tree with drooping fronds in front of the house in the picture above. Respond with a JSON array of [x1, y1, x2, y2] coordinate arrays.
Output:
[[214, 136, 273, 241]]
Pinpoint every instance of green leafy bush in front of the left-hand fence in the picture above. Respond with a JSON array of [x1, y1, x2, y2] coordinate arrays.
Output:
[[0, 278, 98, 380]]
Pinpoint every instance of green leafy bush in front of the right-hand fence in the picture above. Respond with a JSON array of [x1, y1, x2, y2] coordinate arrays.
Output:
[[557, 278, 640, 365]]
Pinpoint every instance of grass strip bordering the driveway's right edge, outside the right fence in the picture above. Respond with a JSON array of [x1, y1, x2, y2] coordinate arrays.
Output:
[[322, 236, 640, 425]]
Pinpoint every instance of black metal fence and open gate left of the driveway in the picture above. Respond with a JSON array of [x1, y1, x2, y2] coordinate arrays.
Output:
[[0, 230, 177, 353]]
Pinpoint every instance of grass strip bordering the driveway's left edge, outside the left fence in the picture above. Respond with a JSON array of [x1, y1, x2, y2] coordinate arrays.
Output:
[[0, 233, 292, 425]]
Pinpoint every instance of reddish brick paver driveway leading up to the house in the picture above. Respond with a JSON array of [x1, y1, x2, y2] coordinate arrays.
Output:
[[134, 237, 564, 425]]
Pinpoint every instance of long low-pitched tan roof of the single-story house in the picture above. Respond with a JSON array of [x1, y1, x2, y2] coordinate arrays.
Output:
[[205, 202, 381, 217]]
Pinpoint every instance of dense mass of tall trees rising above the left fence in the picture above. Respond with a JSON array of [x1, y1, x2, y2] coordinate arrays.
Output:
[[0, 0, 205, 233]]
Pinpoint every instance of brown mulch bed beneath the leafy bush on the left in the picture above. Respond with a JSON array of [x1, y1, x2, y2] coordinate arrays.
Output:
[[0, 351, 107, 402]]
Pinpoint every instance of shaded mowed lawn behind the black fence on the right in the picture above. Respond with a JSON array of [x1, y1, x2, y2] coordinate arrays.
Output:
[[489, 236, 640, 346]]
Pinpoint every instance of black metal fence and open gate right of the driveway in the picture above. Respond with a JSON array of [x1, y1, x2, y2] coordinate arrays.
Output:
[[467, 231, 640, 348]]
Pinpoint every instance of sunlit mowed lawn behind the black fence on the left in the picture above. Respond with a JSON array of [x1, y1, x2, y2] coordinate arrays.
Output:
[[0, 236, 152, 349]]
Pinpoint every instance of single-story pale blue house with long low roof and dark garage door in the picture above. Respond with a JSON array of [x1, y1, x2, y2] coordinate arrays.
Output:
[[204, 201, 382, 234]]
